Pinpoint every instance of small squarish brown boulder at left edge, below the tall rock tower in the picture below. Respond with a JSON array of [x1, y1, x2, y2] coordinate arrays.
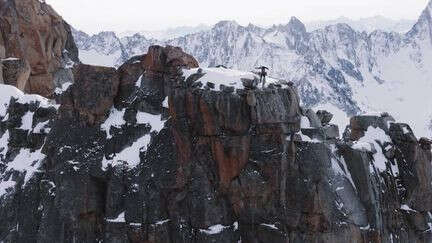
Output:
[[1, 58, 31, 91]]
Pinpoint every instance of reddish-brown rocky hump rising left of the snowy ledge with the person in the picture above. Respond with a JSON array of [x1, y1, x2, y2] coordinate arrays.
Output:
[[60, 46, 198, 126]]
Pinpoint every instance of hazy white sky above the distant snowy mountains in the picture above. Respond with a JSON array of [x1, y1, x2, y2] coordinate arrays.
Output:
[[46, 0, 428, 33]]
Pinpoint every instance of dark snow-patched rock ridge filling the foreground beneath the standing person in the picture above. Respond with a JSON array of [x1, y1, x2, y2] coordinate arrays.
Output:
[[0, 46, 432, 243]]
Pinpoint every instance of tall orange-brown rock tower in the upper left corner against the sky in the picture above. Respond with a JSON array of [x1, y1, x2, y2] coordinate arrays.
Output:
[[0, 0, 77, 97]]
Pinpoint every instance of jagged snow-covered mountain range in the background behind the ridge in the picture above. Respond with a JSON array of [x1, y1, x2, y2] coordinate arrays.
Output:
[[73, 2, 432, 136]]
